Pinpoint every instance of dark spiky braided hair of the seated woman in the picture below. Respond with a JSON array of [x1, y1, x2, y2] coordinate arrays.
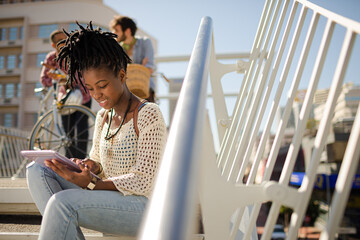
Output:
[[57, 21, 131, 91]]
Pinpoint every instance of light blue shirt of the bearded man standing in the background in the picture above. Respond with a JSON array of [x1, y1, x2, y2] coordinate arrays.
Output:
[[132, 37, 155, 90]]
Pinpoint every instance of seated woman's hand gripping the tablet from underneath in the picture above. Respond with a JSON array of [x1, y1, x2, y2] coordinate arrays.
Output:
[[45, 159, 91, 188]]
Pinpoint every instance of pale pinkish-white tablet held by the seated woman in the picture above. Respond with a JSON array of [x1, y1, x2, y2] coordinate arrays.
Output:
[[21, 150, 99, 178]]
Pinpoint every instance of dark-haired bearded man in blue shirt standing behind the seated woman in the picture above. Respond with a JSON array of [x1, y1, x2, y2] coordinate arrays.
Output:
[[110, 16, 155, 102]]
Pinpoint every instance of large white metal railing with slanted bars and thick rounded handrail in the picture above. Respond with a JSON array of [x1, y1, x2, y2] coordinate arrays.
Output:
[[140, 0, 360, 239]]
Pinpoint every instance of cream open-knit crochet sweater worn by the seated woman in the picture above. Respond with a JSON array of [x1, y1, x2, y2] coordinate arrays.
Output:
[[90, 103, 166, 197]]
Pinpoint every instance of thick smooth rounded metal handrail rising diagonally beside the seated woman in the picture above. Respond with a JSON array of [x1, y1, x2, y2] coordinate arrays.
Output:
[[140, 17, 212, 240]]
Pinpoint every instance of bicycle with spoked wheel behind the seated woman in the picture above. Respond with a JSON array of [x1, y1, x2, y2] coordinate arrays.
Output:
[[29, 66, 95, 158]]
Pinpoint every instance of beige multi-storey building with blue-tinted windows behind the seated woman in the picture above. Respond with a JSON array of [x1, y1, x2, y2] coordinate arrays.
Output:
[[0, 0, 157, 130]]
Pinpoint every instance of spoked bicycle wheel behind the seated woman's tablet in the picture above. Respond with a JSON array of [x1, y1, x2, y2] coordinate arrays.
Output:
[[29, 105, 95, 158]]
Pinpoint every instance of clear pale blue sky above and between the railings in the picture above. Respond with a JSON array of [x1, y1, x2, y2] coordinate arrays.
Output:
[[103, 0, 360, 150]]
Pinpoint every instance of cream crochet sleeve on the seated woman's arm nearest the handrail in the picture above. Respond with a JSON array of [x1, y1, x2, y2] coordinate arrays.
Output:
[[110, 104, 166, 196]]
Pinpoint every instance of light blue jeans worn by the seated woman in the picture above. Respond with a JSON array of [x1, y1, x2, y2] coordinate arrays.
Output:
[[26, 162, 147, 240]]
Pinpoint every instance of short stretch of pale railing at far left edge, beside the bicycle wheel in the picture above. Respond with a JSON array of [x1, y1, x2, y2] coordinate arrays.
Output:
[[0, 126, 29, 178]]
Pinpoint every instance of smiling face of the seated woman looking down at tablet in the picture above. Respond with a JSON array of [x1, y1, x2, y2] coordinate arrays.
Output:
[[82, 67, 125, 109]]
